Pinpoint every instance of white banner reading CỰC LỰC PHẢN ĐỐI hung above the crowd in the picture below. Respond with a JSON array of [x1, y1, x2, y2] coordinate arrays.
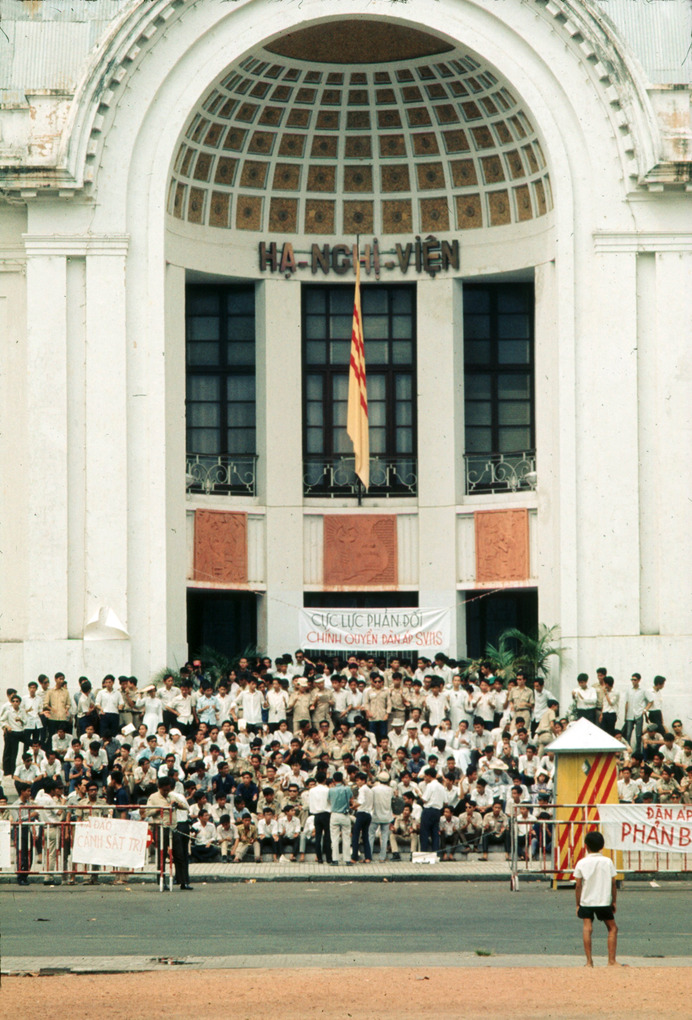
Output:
[[298, 609, 451, 655]]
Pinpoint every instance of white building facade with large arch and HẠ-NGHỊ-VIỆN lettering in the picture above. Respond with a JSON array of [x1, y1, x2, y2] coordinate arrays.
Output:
[[0, 0, 692, 728]]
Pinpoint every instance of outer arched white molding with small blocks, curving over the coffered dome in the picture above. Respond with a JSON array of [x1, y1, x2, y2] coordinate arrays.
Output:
[[59, 0, 659, 201]]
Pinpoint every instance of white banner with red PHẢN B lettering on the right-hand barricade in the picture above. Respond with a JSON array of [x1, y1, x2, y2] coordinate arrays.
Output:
[[598, 804, 692, 854]]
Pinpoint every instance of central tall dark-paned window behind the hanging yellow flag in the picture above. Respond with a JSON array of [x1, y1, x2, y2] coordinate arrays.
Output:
[[303, 285, 415, 495]]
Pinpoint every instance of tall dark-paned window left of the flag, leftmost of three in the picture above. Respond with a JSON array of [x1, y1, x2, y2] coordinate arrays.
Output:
[[186, 285, 255, 492]]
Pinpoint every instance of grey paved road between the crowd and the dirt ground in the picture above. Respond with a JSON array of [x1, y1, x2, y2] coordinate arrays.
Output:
[[0, 882, 692, 960]]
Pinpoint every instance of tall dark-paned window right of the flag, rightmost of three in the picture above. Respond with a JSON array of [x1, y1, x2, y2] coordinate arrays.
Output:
[[463, 284, 535, 491]]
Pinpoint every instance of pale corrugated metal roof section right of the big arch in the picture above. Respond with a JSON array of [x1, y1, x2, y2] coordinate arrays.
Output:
[[596, 0, 692, 85]]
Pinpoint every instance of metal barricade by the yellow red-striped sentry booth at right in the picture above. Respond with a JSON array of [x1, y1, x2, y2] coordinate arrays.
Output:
[[510, 804, 692, 891]]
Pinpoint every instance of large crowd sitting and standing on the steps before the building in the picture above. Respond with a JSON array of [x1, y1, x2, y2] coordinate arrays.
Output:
[[0, 650, 692, 889]]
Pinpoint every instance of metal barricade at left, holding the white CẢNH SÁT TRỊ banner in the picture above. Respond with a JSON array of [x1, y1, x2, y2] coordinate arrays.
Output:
[[0, 802, 174, 891]]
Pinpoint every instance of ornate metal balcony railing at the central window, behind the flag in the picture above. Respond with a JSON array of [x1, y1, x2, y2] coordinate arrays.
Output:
[[303, 456, 418, 499]]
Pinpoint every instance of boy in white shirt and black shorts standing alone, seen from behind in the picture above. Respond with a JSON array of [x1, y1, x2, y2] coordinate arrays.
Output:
[[575, 832, 620, 967]]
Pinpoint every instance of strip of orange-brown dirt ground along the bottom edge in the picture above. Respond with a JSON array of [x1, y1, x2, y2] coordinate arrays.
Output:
[[0, 965, 692, 1020]]
